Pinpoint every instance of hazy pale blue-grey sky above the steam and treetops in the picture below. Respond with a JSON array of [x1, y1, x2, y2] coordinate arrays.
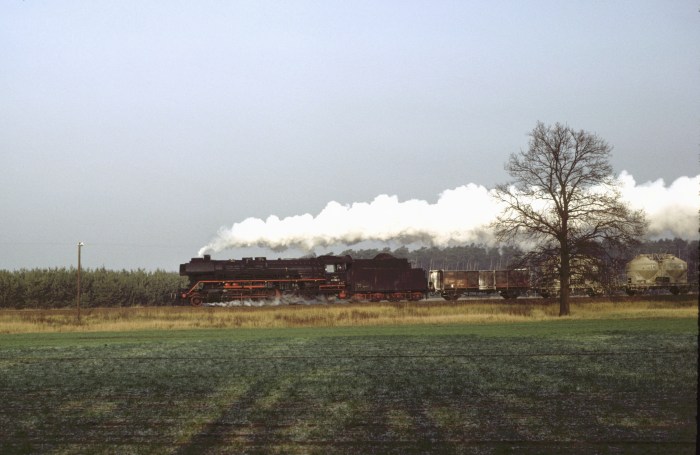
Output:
[[0, 0, 700, 271]]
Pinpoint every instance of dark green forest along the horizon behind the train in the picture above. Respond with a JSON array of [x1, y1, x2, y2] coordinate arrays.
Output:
[[0, 239, 698, 308]]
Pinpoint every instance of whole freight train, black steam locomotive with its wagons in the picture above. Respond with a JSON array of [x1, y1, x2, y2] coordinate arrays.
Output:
[[177, 253, 689, 306]]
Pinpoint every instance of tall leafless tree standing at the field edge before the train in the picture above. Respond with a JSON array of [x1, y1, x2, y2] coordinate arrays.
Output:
[[494, 122, 647, 316]]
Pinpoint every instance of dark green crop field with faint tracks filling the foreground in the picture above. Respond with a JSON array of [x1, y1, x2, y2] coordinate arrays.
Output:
[[0, 317, 698, 454]]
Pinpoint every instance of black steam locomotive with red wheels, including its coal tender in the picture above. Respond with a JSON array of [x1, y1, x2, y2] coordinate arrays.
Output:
[[178, 254, 427, 306]]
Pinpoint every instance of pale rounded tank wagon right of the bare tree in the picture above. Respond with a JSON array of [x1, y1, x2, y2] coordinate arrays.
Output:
[[625, 254, 690, 295]]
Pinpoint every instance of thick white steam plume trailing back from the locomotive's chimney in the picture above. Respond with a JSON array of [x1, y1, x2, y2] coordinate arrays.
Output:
[[199, 171, 700, 256]]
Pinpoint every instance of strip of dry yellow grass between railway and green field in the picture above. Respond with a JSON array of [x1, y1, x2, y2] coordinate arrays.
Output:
[[0, 296, 698, 333]]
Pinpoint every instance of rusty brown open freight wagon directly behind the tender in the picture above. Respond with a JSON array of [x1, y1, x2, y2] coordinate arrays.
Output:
[[428, 269, 530, 300]]
